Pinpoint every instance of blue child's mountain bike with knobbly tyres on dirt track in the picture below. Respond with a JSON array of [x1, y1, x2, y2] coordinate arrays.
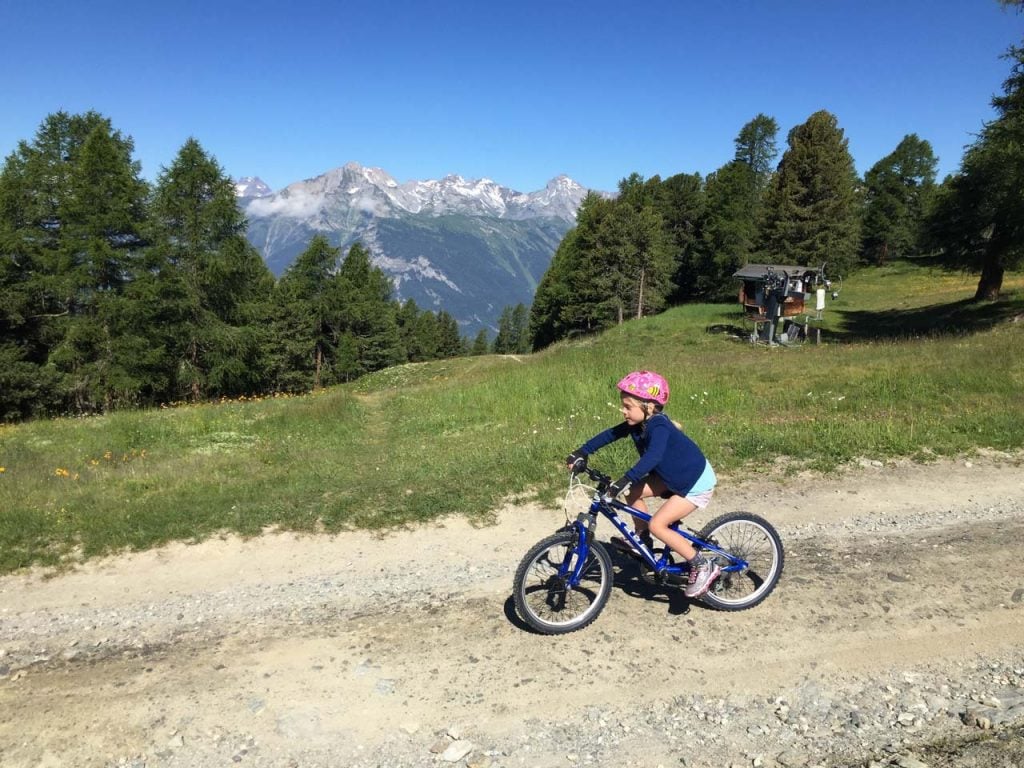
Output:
[[513, 467, 784, 635]]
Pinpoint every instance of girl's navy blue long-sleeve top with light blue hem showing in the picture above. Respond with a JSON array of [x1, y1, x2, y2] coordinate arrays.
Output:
[[580, 414, 715, 496]]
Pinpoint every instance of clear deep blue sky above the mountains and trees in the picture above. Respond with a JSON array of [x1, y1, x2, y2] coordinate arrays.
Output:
[[6, 0, 1024, 191]]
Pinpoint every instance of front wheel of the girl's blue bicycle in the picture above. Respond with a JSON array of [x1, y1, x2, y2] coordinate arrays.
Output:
[[513, 530, 614, 635]]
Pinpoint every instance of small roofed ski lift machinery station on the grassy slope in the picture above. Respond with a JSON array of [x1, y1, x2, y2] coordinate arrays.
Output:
[[732, 264, 843, 346]]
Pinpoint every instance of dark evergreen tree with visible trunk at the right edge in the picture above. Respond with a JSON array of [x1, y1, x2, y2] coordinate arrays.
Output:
[[929, 40, 1024, 299]]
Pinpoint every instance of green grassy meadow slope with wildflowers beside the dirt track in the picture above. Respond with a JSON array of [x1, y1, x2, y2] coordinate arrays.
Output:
[[0, 263, 1024, 572]]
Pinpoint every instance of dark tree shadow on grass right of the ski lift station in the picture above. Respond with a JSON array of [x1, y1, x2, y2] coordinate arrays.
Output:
[[828, 292, 1024, 341]]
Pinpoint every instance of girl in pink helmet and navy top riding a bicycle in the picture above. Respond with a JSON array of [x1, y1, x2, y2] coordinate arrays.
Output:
[[566, 371, 721, 598]]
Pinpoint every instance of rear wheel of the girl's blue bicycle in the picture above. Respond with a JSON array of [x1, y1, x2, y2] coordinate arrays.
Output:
[[697, 512, 785, 611]]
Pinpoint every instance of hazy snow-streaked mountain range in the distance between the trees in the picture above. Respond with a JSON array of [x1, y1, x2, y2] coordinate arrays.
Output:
[[239, 163, 588, 335]]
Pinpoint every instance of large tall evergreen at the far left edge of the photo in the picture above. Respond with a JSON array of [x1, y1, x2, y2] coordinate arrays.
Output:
[[0, 112, 146, 415]]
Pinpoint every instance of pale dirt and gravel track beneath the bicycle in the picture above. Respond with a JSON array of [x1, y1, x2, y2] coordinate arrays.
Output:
[[0, 457, 1024, 768]]
